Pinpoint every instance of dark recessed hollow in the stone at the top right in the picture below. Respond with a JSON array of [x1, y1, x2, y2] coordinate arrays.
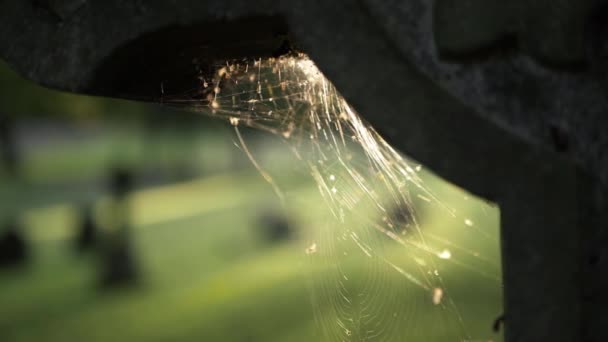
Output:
[[434, 0, 592, 66]]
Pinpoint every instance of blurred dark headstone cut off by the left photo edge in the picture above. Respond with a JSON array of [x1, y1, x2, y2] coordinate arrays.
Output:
[[0, 219, 28, 267]]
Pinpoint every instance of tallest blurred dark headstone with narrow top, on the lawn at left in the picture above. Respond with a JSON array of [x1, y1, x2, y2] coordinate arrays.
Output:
[[101, 168, 138, 288]]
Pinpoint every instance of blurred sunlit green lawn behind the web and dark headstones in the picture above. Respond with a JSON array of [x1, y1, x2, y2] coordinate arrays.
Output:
[[0, 126, 501, 341]]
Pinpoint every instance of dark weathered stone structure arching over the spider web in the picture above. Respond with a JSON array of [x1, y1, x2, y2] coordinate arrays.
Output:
[[0, 0, 608, 341]]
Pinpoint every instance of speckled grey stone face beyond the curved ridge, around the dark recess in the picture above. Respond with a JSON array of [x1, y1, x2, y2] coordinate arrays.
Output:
[[360, 0, 608, 190]]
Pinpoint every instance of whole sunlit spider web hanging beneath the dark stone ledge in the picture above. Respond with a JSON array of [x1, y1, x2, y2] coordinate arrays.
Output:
[[163, 54, 502, 341]]
